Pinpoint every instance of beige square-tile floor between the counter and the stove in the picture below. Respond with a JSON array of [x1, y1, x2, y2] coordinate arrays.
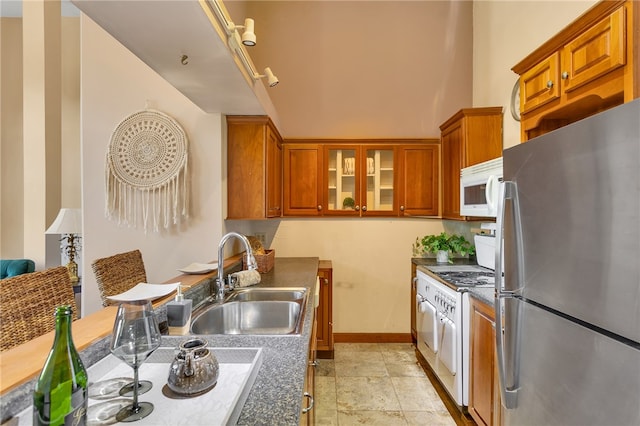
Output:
[[314, 343, 456, 426]]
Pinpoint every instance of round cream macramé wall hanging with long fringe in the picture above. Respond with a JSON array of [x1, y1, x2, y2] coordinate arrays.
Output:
[[105, 109, 188, 233]]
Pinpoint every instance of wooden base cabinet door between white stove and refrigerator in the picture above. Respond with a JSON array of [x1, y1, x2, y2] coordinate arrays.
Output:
[[469, 297, 501, 426]]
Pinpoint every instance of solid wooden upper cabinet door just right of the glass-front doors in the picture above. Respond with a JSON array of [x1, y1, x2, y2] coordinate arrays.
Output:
[[398, 143, 440, 216]]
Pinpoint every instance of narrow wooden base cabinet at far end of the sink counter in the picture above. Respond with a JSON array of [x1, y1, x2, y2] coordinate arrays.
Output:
[[316, 260, 334, 359]]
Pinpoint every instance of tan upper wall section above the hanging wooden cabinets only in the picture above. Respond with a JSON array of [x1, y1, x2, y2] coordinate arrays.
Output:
[[232, 1, 473, 138]]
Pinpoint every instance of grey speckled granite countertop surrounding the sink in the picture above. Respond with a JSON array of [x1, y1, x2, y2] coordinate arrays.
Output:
[[2, 257, 319, 425]]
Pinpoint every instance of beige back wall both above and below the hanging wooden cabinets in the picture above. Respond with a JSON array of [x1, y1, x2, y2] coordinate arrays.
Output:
[[226, 1, 472, 333]]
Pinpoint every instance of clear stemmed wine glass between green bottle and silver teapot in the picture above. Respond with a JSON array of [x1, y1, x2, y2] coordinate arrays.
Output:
[[110, 300, 160, 422]]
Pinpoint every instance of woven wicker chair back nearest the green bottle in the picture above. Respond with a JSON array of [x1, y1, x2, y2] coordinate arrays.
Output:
[[0, 266, 78, 351]]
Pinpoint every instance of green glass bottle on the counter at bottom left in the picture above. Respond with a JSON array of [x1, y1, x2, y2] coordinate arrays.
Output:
[[33, 305, 88, 426]]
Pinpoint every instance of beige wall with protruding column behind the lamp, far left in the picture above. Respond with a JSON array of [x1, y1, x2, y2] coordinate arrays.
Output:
[[0, 8, 81, 269]]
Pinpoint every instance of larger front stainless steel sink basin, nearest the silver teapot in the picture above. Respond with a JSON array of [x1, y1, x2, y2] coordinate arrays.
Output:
[[191, 300, 304, 334]]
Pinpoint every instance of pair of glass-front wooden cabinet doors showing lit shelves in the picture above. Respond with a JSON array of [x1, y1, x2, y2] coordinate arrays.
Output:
[[324, 145, 398, 216]]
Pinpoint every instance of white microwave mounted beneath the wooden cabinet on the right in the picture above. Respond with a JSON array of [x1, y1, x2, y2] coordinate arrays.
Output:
[[460, 157, 502, 217]]
